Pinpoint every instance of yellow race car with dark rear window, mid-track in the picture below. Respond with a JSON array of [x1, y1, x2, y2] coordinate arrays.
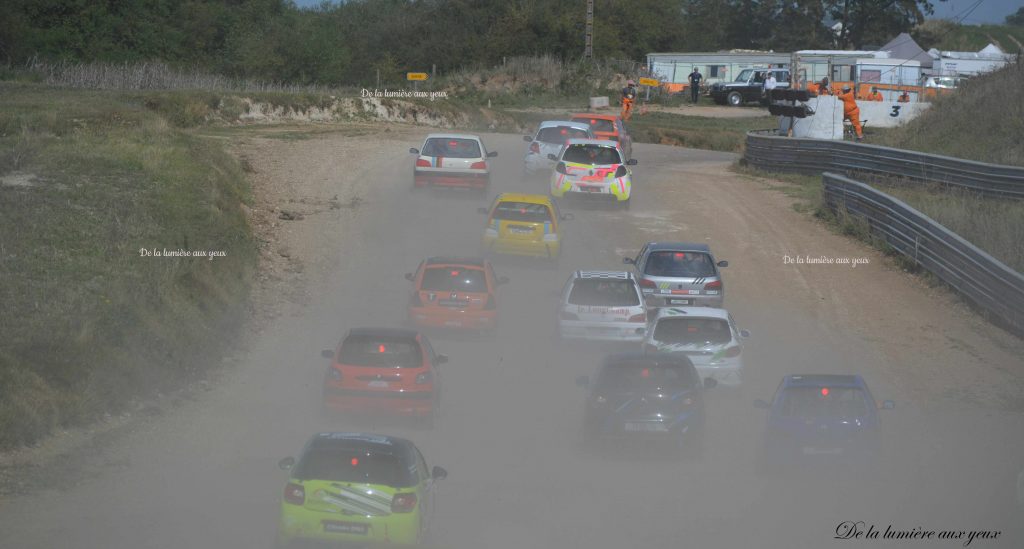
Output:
[[478, 193, 572, 260]]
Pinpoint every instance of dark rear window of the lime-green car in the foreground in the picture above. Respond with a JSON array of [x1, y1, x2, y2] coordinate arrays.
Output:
[[293, 440, 416, 487]]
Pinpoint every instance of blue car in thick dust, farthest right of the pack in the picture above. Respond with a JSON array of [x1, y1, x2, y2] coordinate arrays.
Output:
[[754, 375, 895, 467]]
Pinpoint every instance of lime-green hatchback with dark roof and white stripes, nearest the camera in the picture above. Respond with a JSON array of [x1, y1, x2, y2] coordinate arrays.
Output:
[[278, 432, 447, 548]]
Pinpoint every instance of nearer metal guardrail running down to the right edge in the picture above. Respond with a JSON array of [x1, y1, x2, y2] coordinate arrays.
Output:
[[821, 172, 1024, 334]]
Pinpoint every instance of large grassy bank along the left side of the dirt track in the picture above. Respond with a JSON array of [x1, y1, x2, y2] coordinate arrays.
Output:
[[0, 82, 256, 448]]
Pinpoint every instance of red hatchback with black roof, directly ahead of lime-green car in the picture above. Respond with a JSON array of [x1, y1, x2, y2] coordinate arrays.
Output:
[[323, 328, 447, 425]]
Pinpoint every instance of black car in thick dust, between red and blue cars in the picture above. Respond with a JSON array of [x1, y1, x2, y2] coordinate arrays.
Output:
[[577, 352, 717, 455]]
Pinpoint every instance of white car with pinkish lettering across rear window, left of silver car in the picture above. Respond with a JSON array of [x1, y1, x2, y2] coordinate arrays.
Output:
[[558, 270, 647, 342]]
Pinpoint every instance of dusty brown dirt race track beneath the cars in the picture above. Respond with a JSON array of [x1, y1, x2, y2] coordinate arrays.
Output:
[[0, 127, 1024, 549]]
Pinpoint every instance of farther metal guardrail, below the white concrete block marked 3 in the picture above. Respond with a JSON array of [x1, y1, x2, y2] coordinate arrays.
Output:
[[743, 130, 1024, 199]]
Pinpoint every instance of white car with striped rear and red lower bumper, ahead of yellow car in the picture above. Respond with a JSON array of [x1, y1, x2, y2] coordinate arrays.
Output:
[[409, 133, 498, 192]]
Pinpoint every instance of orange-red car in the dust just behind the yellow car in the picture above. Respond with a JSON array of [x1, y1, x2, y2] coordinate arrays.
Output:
[[406, 257, 509, 331]]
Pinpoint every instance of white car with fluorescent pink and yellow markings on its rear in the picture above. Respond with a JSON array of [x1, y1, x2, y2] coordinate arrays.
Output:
[[548, 139, 637, 208]]
